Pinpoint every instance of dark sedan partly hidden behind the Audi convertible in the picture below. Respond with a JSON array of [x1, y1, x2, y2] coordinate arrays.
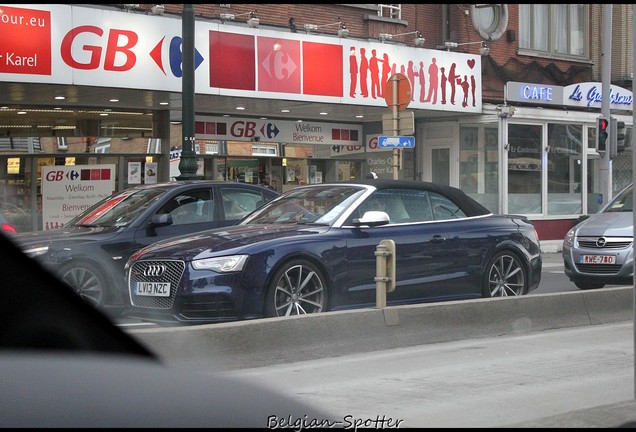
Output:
[[11, 180, 278, 313]]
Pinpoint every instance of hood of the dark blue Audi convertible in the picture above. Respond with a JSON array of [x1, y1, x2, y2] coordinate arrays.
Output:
[[134, 225, 329, 260]]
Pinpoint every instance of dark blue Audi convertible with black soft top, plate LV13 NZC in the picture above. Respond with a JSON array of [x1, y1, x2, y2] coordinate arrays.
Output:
[[126, 180, 541, 323]]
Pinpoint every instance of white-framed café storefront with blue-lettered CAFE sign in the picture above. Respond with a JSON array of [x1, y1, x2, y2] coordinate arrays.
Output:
[[416, 82, 633, 246]]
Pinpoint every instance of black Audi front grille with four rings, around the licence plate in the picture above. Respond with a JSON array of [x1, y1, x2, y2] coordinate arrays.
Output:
[[128, 261, 185, 309]]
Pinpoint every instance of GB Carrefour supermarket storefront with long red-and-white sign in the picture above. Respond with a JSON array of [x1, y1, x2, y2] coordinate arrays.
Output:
[[0, 4, 482, 230]]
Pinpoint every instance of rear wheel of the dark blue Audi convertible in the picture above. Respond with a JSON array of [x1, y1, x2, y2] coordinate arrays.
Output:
[[482, 251, 528, 298]]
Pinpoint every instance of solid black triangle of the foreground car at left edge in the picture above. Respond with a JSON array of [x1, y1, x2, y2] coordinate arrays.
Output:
[[0, 231, 156, 359]]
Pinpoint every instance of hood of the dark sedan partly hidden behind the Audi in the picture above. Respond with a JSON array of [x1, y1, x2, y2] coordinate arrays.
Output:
[[11, 226, 122, 249]]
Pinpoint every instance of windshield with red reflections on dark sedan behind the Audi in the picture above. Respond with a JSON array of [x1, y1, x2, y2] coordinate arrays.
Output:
[[67, 188, 165, 227]]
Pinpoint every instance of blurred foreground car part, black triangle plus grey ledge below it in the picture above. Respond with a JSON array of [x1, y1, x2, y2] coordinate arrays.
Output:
[[0, 234, 329, 428]]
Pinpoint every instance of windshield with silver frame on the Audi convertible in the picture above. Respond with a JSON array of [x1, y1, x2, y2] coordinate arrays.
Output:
[[240, 185, 366, 225]]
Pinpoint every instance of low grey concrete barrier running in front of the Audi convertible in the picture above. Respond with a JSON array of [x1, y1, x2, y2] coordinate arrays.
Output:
[[128, 287, 634, 371]]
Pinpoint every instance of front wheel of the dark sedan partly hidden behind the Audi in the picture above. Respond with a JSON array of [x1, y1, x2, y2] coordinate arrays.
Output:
[[58, 262, 106, 308]]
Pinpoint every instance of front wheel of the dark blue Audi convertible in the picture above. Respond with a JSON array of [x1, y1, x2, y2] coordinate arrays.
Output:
[[265, 259, 328, 317]]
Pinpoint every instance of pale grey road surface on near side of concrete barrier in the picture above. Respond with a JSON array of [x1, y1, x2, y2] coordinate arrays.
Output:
[[220, 322, 636, 428]]
